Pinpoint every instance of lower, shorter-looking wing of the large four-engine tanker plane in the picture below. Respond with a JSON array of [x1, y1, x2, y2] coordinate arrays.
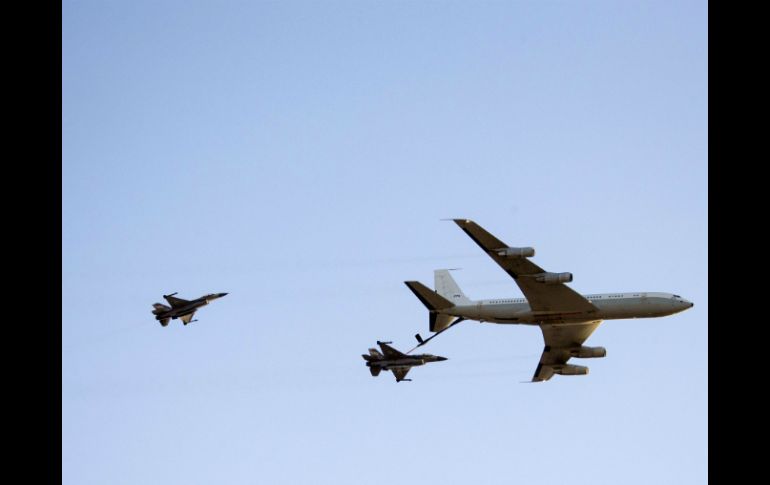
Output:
[[532, 320, 602, 382]]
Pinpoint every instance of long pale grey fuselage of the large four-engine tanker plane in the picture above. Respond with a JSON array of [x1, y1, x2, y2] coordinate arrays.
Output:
[[443, 292, 693, 325]]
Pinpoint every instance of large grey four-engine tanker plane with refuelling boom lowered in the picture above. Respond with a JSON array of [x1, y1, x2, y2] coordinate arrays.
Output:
[[405, 219, 693, 382]]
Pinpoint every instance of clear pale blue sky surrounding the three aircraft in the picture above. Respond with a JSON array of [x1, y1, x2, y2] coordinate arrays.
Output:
[[62, 1, 708, 485]]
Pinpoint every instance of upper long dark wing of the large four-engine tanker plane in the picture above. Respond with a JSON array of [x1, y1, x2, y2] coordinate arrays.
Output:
[[454, 219, 597, 313]]
